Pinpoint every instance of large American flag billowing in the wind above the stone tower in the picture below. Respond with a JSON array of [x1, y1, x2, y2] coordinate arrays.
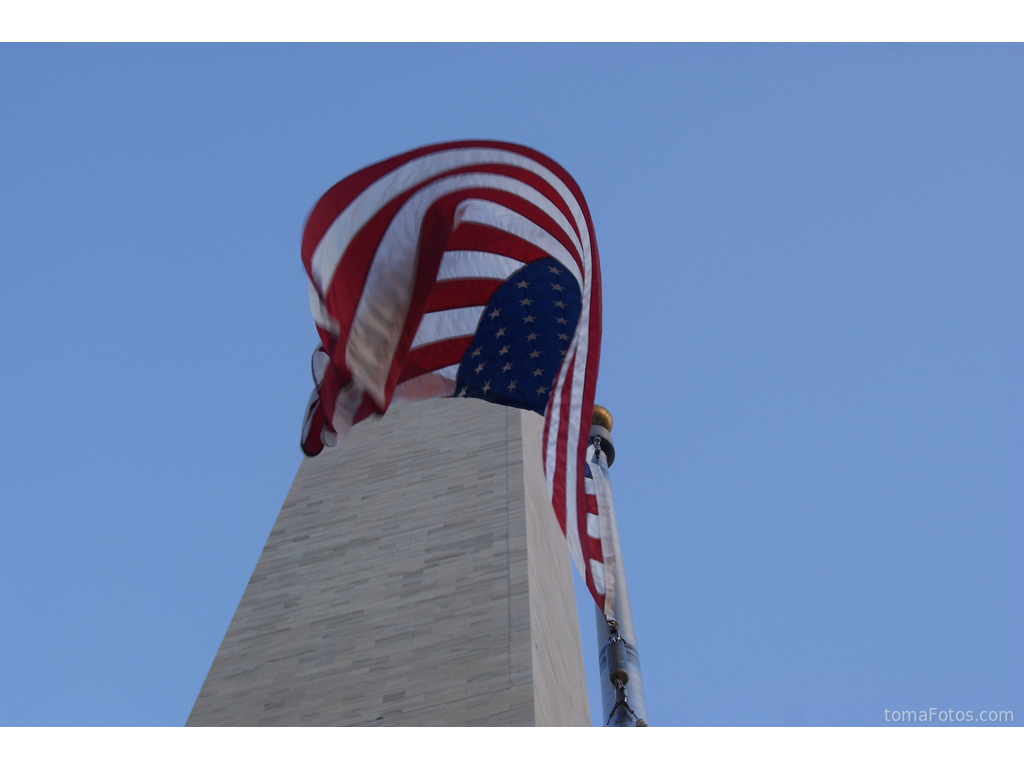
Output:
[[302, 141, 612, 611]]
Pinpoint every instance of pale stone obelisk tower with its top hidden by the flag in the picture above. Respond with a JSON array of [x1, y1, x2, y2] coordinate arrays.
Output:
[[187, 399, 590, 725]]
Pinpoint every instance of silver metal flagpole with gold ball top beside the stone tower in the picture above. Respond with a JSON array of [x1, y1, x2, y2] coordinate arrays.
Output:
[[590, 406, 647, 727]]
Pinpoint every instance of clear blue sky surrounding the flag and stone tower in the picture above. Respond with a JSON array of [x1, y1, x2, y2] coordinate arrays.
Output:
[[0, 45, 1024, 725]]
